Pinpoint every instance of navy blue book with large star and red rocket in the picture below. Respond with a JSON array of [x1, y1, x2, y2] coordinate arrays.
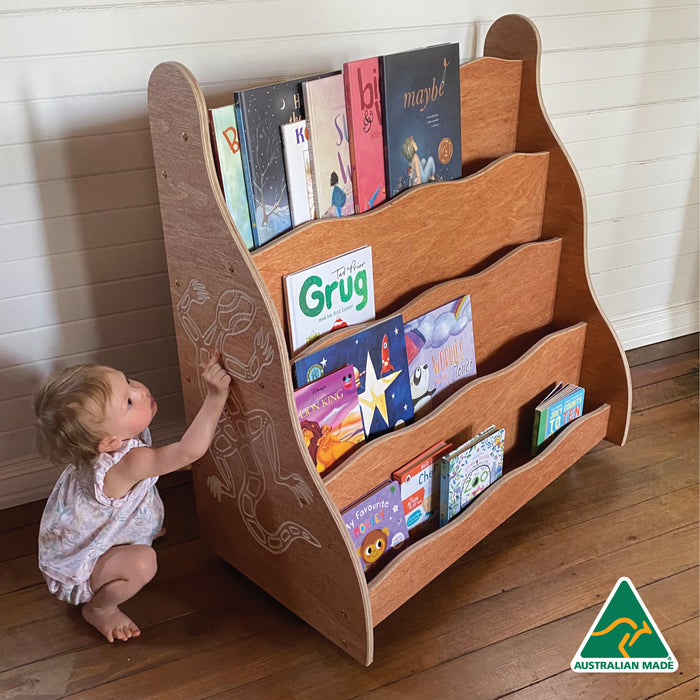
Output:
[[292, 314, 413, 438]]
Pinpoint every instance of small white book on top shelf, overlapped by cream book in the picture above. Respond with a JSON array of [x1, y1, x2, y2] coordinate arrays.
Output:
[[280, 119, 316, 226]]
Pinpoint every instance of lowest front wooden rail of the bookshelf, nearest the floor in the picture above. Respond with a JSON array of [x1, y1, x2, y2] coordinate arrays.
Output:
[[369, 404, 610, 625]]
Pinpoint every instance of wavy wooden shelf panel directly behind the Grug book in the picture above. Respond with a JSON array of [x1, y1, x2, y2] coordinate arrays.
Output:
[[252, 153, 549, 330]]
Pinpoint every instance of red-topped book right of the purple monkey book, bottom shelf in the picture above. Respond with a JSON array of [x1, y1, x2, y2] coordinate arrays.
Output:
[[391, 441, 452, 540]]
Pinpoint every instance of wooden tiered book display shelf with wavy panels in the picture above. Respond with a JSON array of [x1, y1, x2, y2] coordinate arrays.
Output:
[[149, 15, 631, 664]]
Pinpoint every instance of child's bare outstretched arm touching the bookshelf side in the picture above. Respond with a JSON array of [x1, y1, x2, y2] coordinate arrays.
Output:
[[104, 350, 231, 498]]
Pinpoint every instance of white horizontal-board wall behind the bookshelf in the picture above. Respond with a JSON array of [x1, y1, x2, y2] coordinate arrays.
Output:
[[0, 0, 698, 507]]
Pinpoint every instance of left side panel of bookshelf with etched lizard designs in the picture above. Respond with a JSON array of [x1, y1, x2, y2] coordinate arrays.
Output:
[[149, 63, 373, 664]]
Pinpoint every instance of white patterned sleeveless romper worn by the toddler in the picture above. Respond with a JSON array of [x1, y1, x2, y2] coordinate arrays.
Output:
[[39, 428, 163, 605]]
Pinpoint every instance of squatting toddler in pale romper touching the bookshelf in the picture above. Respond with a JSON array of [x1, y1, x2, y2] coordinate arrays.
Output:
[[34, 351, 231, 642]]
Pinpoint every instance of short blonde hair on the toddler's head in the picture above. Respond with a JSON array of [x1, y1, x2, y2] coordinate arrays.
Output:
[[34, 365, 112, 467]]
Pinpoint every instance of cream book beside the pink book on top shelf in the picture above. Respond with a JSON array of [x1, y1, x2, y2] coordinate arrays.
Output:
[[304, 72, 355, 219]]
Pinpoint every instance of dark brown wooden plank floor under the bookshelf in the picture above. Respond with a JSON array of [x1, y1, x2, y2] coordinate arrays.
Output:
[[0, 335, 698, 700]]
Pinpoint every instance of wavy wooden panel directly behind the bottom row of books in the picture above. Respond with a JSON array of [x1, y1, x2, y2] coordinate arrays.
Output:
[[326, 323, 591, 508]]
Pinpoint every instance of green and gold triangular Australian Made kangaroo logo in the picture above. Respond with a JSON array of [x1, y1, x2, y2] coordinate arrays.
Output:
[[571, 576, 678, 673]]
